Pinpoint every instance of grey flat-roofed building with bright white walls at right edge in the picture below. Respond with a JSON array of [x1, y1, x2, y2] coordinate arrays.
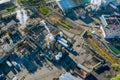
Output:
[[100, 15, 120, 39]]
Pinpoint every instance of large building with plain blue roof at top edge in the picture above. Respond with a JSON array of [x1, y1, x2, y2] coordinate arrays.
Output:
[[56, 0, 84, 12]]
